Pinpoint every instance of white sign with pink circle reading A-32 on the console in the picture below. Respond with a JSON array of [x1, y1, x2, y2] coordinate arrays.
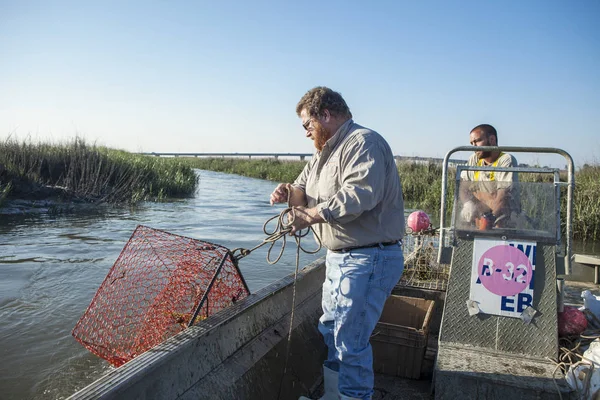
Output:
[[469, 239, 537, 318]]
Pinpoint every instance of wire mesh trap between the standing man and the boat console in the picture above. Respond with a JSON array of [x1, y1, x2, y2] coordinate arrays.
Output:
[[398, 228, 450, 291]]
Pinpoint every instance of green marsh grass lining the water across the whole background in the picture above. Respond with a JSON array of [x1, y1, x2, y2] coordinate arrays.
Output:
[[0, 138, 600, 240]]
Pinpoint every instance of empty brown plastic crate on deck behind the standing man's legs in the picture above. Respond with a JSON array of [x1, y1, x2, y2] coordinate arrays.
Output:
[[371, 295, 435, 379]]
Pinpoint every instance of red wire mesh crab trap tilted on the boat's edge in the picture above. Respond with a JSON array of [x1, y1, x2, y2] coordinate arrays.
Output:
[[72, 225, 250, 366]]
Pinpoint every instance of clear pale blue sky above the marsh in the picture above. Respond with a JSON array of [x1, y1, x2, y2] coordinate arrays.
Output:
[[0, 0, 600, 165]]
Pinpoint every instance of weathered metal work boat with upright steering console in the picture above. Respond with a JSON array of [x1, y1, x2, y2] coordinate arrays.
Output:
[[69, 146, 588, 400]]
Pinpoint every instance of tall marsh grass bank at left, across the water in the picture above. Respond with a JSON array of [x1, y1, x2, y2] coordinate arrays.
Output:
[[0, 138, 198, 205]]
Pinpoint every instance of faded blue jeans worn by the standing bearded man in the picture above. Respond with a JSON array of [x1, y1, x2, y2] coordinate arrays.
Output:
[[319, 244, 404, 399]]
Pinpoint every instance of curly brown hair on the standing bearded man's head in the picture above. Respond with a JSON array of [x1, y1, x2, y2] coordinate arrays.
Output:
[[296, 86, 352, 118]]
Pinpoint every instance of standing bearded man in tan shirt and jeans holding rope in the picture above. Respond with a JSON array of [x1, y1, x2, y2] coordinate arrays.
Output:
[[270, 87, 404, 400]]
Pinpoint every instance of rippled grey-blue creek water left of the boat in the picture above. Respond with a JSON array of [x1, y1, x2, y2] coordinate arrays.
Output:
[[0, 171, 324, 399]]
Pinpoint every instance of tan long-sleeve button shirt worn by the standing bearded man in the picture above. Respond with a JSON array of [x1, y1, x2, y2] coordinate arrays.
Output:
[[294, 119, 404, 250]]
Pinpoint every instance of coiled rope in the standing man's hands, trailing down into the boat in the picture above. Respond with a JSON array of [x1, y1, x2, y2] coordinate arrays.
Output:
[[231, 202, 322, 399]]
